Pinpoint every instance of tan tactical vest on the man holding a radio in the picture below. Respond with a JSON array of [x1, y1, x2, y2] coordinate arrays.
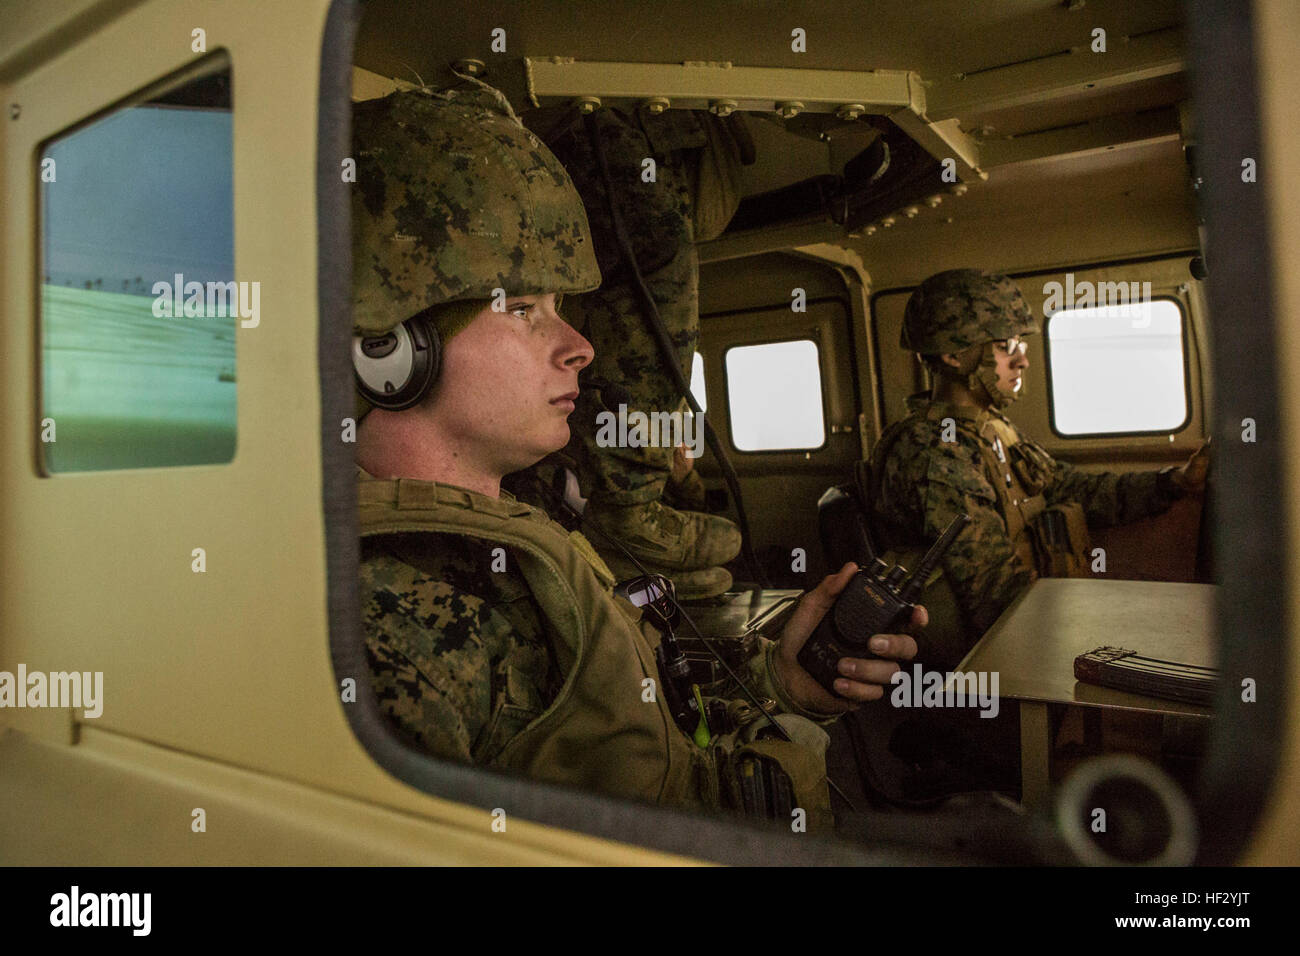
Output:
[[359, 476, 829, 830]]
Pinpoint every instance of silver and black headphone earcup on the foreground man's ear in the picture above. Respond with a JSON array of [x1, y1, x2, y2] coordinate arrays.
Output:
[[352, 312, 442, 411]]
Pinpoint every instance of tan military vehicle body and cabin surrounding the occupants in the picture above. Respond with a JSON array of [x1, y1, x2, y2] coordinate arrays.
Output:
[[0, 0, 1300, 865]]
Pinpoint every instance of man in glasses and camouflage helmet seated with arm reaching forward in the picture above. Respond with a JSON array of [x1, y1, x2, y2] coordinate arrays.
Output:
[[865, 269, 1209, 665]]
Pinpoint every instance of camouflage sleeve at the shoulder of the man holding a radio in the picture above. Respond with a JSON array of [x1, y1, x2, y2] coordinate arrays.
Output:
[[361, 557, 508, 762]]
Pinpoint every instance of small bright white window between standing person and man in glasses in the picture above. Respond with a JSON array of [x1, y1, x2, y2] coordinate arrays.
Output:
[[724, 338, 826, 451]]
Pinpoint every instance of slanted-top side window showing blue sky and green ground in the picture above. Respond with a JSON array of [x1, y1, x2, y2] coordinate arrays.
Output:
[[36, 55, 236, 473]]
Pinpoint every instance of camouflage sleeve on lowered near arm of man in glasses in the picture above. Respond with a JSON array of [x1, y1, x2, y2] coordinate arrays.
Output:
[[924, 451, 1032, 636]]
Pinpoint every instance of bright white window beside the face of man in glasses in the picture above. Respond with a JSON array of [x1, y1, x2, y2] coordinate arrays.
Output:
[[1047, 299, 1188, 437]]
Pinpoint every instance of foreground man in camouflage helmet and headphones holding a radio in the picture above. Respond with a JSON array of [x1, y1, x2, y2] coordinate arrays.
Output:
[[352, 81, 924, 818]]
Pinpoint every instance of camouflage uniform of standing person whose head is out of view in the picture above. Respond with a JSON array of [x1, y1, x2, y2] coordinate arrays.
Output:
[[515, 108, 741, 600]]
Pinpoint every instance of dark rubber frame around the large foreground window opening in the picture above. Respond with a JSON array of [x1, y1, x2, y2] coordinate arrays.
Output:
[[316, 0, 1291, 865]]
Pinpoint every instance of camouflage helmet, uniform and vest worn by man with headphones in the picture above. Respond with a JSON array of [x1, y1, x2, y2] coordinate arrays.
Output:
[[352, 82, 828, 821]]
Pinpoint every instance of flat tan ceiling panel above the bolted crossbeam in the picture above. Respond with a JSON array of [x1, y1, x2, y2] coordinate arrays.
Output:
[[356, 0, 1182, 86]]
